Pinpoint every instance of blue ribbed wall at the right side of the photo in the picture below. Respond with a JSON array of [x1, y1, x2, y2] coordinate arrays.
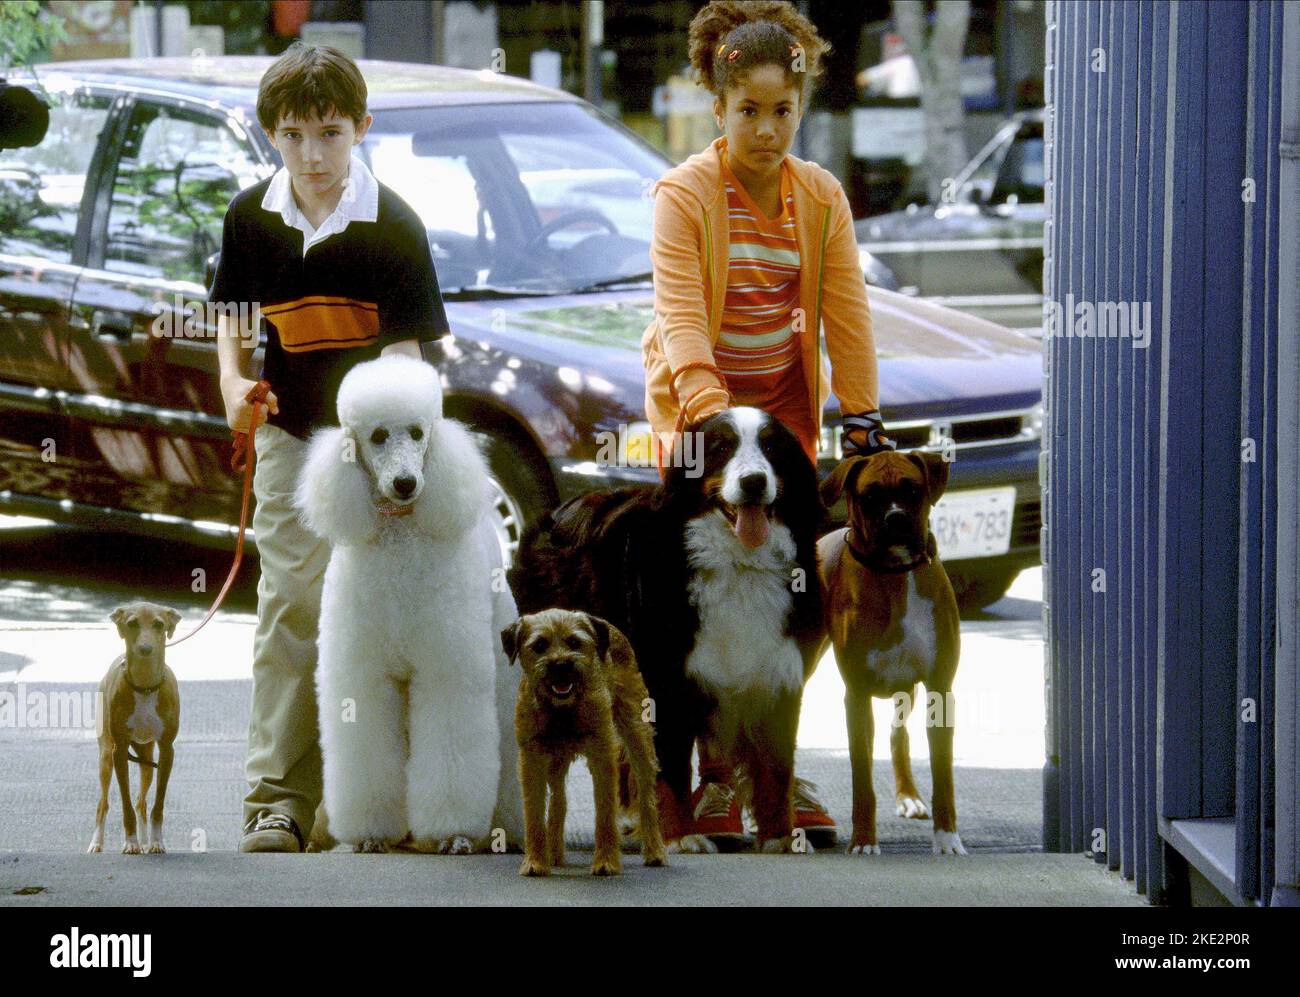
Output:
[[1043, 0, 1295, 902]]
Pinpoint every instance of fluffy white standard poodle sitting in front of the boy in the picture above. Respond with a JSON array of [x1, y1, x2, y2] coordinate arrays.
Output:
[[295, 356, 523, 854]]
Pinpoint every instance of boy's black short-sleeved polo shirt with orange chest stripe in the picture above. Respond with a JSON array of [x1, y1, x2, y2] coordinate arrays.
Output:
[[208, 178, 450, 439]]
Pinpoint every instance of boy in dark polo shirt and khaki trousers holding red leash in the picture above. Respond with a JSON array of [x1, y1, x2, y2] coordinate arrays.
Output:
[[209, 44, 449, 851]]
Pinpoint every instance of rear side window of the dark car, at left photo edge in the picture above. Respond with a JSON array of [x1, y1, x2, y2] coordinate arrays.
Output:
[[0, 92, 111, 263]]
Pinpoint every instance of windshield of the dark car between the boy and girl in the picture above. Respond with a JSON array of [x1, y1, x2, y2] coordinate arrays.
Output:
[[361, 103, 670, 294]]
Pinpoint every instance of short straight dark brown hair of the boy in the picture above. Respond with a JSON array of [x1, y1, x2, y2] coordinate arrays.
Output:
[[257, 42, 365, 131]]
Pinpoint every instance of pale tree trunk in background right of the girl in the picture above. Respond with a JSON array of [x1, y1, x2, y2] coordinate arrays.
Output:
[[893, 0, 971, 203]]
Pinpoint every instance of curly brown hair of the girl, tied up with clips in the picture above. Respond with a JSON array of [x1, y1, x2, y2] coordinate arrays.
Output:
[[690, 0, 831, 107]]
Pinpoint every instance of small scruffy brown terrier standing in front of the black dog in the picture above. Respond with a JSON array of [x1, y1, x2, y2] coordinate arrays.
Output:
[[501, 610, 667, 876]]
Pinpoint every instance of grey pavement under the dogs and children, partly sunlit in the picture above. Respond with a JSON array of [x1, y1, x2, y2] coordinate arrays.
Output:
[[0, 551, 1145, 906]]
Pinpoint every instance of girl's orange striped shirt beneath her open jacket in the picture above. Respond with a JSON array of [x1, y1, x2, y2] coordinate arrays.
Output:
[[714, 159, 816, 448]]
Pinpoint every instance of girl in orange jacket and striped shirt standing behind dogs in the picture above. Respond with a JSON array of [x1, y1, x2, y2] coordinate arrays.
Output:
[[642, 3, 893, 844]]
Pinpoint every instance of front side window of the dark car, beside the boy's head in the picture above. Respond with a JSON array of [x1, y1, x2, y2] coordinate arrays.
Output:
[[104, 104, 269, 283]]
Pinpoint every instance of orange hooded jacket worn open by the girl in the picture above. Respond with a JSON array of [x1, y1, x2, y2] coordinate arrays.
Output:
[[641, 138, 879, 462]]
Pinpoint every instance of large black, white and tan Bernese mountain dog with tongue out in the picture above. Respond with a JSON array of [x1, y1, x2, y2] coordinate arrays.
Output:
[[510, 407, 824, 851]]
